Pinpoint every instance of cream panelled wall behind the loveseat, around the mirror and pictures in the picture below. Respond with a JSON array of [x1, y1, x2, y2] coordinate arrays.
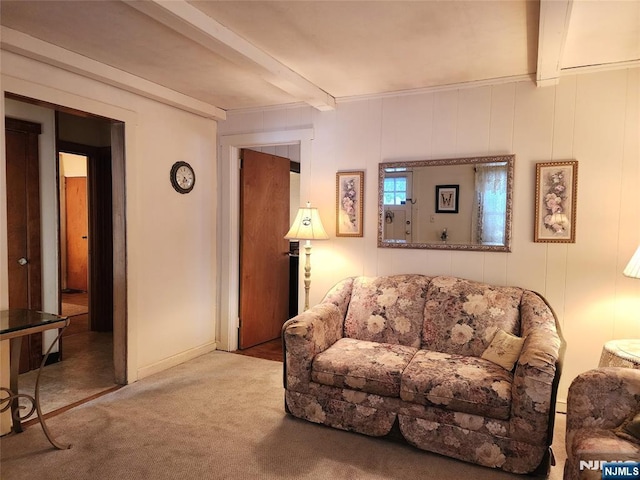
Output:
[[219, 68, 640, 402]]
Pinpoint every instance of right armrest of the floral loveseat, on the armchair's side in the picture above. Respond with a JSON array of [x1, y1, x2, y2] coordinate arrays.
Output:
[[511, 291, 565, 445]]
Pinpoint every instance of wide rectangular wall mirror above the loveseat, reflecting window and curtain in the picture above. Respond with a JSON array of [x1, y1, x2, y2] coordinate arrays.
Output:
[[378, 155, 515, 252]]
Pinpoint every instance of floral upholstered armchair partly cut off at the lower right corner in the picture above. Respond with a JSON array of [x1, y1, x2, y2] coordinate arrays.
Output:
[[564, 367, 640, 480]]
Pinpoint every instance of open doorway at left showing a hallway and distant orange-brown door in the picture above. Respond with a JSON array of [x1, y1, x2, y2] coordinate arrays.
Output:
[[56, 112, 116, 408]]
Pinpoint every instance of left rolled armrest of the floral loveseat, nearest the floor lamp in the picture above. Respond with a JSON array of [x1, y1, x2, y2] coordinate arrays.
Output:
[[282, 303, 344, 393]]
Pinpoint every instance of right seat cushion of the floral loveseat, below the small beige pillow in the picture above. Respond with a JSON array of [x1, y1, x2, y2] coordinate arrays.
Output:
[[400, 350, 513, 420]]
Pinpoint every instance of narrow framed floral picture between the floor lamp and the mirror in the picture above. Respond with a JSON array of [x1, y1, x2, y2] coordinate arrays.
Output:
[[336, 171, 364, 237]]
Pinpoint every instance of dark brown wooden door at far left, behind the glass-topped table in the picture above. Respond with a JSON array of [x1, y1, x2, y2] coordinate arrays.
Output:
[[5, 118, 42, 373]]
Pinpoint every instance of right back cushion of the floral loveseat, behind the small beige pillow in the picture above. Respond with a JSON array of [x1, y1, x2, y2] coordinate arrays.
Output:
[[422, 277, 523, 357]]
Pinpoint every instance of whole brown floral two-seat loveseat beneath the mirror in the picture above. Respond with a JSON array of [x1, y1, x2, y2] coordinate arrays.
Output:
[[283, 275, 564, 473]]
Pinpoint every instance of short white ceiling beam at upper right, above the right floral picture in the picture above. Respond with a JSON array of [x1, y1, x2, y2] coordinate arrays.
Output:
[[536, 0, 573, 87]]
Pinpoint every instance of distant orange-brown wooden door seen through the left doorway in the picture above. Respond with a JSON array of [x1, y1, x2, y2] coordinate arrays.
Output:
[[65, 177, 89, 292]]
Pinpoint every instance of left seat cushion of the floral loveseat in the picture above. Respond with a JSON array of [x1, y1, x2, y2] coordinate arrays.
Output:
[[311, 338, 418, 397]]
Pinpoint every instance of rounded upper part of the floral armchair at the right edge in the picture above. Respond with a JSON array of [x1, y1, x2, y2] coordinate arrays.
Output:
[[567, 367, 640, 434]]
